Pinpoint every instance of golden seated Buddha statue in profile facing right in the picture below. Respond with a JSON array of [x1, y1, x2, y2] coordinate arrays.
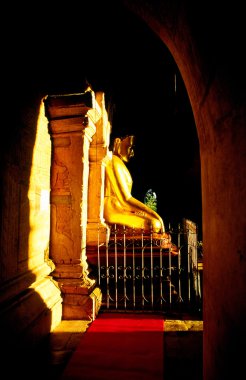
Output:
[[104, 136, 165, 234]]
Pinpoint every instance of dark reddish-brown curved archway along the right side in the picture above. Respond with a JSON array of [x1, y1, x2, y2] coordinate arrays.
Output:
[[122, 1, 246, 379]]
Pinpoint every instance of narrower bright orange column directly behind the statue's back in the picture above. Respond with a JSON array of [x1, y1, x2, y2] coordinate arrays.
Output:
[[87, 92, 111, 248]]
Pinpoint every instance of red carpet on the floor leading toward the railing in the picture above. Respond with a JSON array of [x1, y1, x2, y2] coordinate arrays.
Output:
[[62, 313, 164, 380]]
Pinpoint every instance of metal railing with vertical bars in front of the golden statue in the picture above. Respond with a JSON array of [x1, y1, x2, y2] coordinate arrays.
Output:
[[89, 221, 202, 313]]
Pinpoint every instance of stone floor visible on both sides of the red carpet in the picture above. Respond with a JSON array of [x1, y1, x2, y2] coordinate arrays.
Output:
[[49, 319, 203, 380]]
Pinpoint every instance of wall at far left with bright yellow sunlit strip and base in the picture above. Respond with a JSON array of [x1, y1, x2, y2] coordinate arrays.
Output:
[[0, 100, 62, 348]]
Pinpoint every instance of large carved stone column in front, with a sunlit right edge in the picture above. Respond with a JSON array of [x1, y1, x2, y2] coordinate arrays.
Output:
[[45, 91, 101, 319]]
